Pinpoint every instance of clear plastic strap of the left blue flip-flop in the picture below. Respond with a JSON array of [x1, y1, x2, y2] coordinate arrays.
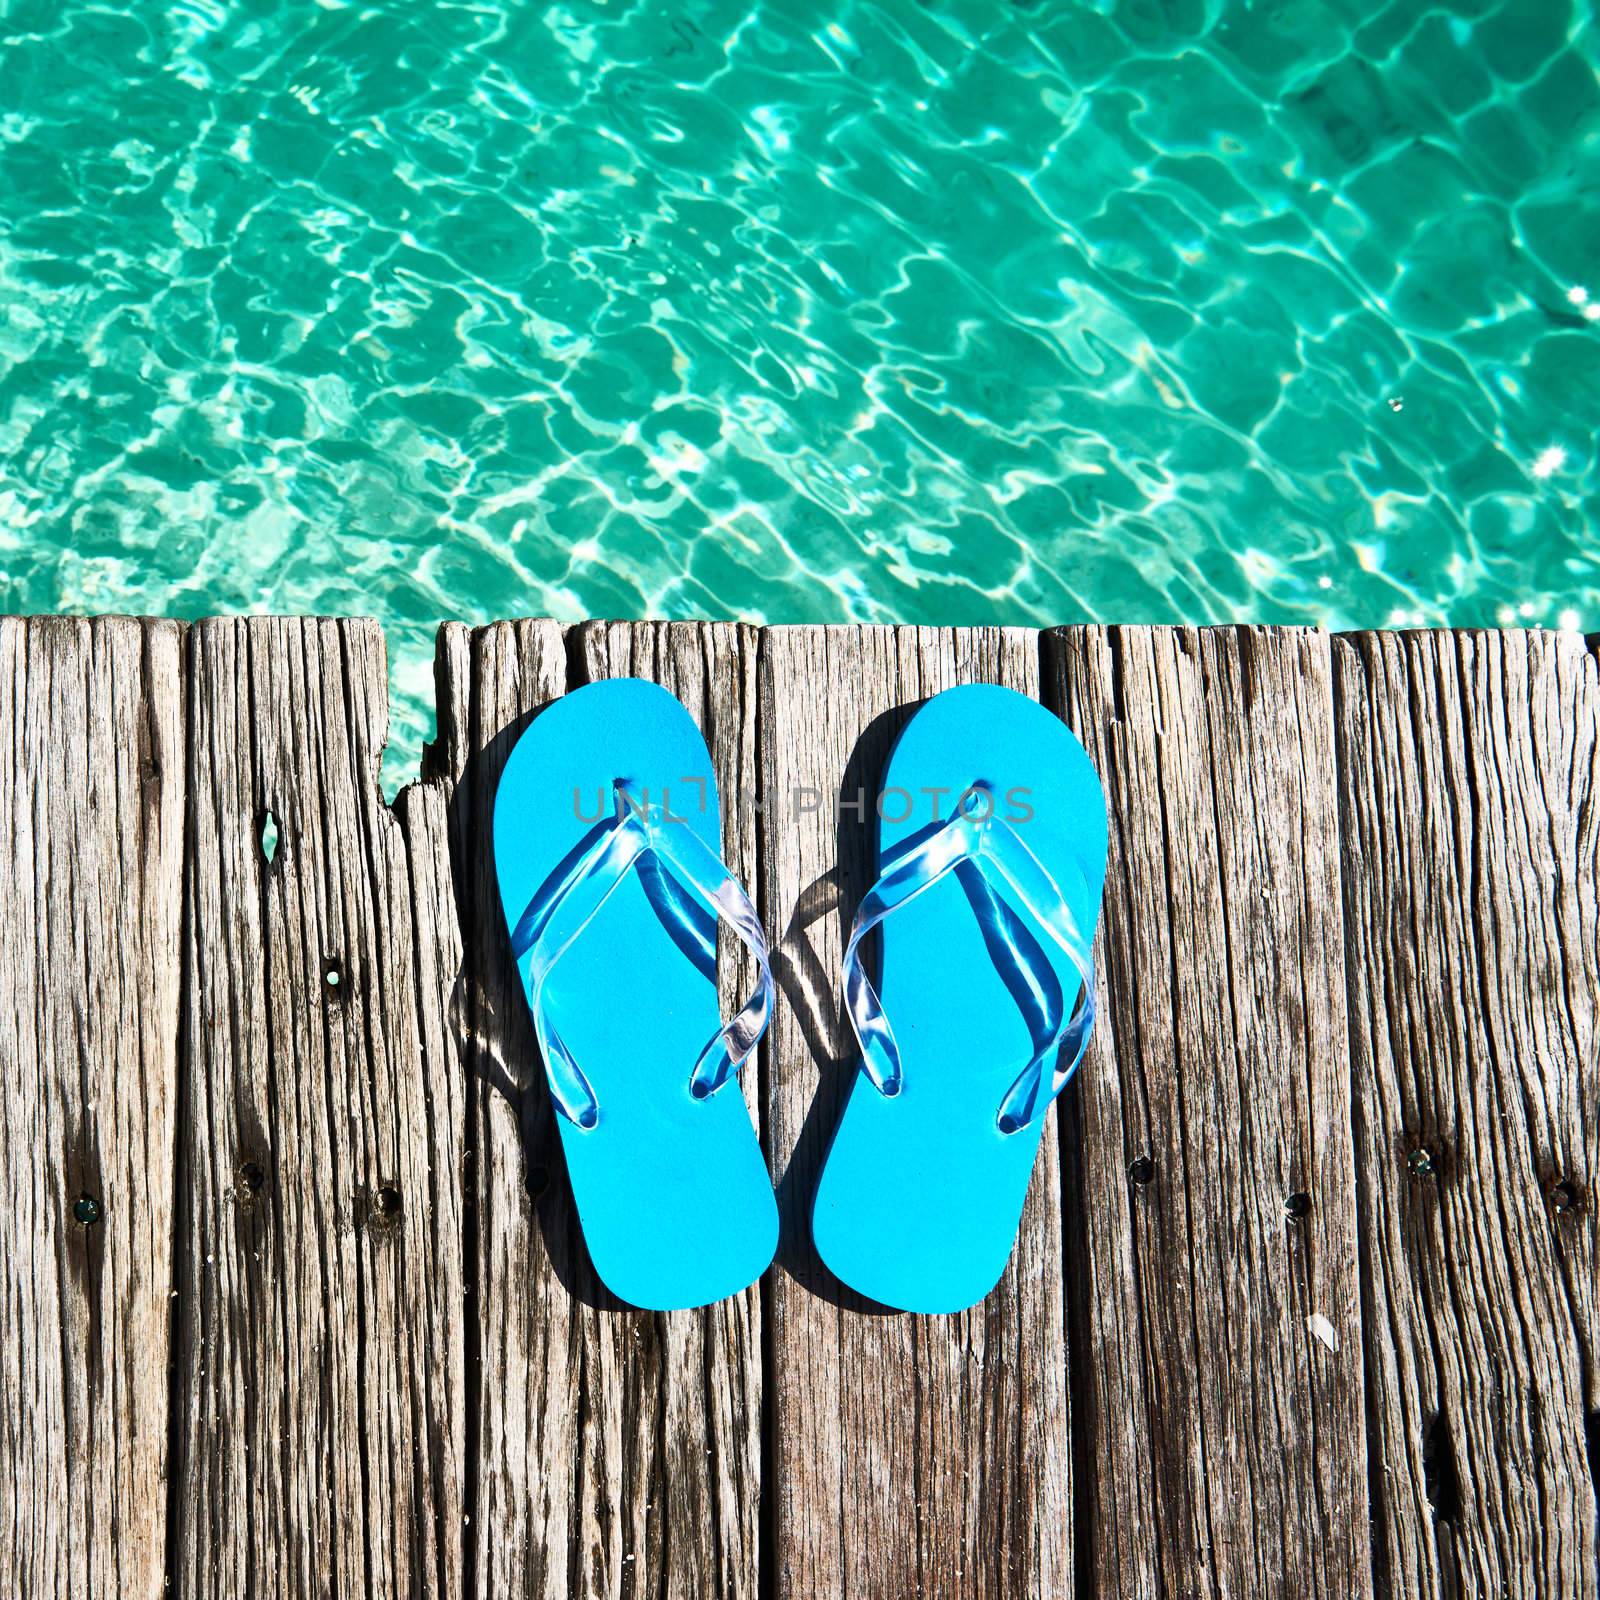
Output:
[[512, 782, 773, 1130]]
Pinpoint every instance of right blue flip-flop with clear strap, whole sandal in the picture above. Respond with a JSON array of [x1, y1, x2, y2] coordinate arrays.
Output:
[[811, 685, 1106, 1312]]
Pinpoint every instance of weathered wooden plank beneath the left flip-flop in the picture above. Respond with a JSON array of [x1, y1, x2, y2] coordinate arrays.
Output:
[[458, 622, 760, 1600]]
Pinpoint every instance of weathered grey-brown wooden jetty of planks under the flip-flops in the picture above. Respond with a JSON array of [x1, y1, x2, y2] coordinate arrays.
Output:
[[0, 618, 1600, 1600]]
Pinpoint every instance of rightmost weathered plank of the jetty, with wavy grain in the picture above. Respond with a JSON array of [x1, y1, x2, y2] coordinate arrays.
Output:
[[1334, 632, 1600, 1600]]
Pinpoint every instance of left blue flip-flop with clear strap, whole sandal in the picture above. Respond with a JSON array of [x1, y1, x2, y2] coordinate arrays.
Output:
[[494, 678, 778, 1310]]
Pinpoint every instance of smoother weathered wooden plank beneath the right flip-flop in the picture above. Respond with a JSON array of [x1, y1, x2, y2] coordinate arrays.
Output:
[[762, 627, 1072, 1600]]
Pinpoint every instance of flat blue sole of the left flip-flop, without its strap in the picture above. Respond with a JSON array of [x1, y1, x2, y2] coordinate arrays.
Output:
[[494, 678, 778, 1310]]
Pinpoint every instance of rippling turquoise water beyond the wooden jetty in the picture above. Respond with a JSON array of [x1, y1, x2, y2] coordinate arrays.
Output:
[[0, 0, 1600, 770]]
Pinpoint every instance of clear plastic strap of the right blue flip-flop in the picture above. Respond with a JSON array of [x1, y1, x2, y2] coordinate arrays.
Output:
[[843, 784, 1094, 1133]]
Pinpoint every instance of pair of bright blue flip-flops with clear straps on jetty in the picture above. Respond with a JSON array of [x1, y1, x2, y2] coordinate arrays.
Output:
[[494, 678, 1106, 1312]]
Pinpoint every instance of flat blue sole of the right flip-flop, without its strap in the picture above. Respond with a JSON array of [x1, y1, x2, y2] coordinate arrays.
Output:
[[811, 685, 1106, 1312]]
